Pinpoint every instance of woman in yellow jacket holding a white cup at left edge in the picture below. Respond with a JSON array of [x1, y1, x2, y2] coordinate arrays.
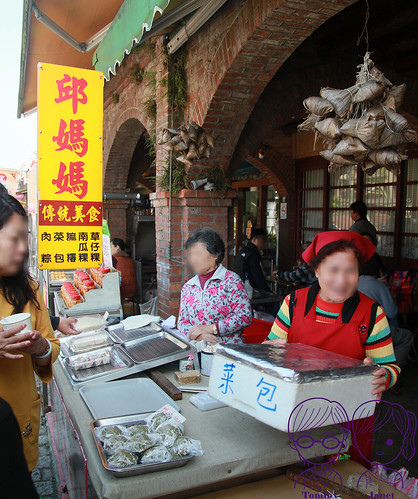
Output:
[[0, 194, 60, 471]]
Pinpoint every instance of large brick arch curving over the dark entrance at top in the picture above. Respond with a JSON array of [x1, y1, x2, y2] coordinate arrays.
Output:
[[186, 0, 355, 174]]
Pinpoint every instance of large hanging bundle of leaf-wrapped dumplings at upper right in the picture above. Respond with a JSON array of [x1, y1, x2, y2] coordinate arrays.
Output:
[[298, 53, 417, 175]]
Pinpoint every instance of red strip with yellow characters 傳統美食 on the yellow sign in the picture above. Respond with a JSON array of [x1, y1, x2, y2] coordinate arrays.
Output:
[[39, 201, 102, 226]]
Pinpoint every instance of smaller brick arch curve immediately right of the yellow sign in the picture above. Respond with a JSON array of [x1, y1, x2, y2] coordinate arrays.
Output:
[[104, 118, 145, 192]]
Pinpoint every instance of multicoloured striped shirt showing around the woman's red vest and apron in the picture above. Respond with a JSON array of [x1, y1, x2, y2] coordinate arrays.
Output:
[[268, 295, 400, 388]]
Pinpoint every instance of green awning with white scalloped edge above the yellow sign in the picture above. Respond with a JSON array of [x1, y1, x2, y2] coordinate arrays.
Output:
[[93, 0, 170, 80]]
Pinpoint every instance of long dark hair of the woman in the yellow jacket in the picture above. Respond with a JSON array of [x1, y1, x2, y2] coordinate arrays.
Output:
[[0, 193, 40, 314]]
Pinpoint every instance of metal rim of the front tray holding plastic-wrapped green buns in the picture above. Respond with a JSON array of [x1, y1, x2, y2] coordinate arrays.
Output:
[[90, 414, 193, 478]]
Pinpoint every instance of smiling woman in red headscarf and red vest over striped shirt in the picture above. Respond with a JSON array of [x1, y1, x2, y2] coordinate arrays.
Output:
[[267, 231, 400, 461]]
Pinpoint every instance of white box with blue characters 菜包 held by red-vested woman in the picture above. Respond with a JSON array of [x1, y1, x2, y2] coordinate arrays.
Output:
[[209, 343, 377, 433]]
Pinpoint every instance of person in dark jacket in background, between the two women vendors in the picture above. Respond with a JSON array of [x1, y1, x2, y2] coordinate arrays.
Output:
[[234, 227, 270, 291]]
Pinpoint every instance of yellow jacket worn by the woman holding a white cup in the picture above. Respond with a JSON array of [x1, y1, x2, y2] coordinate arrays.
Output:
[[0, 289, 60, 471]]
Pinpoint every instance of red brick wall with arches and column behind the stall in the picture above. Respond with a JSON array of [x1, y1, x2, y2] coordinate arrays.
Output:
[[99, 0, 354, 315]]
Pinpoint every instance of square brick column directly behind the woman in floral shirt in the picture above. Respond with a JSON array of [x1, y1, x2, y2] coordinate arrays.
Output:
[[150, 190, 236, 317]]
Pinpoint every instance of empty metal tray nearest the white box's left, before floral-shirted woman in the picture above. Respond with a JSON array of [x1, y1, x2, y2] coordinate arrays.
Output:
[[121, 331, 189, 364]]
